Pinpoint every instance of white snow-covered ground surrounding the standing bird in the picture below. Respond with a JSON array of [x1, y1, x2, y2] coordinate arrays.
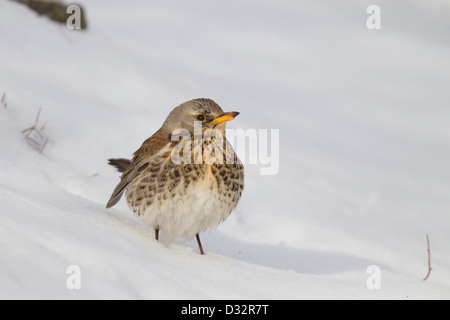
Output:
[[0, 0, 450, 299]]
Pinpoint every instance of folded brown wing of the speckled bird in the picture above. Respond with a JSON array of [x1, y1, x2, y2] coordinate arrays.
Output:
[[106, 129, 172, 208]]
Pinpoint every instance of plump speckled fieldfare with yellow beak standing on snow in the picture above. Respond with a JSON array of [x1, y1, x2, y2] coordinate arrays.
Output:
[[106, 98, 244, 254]]
